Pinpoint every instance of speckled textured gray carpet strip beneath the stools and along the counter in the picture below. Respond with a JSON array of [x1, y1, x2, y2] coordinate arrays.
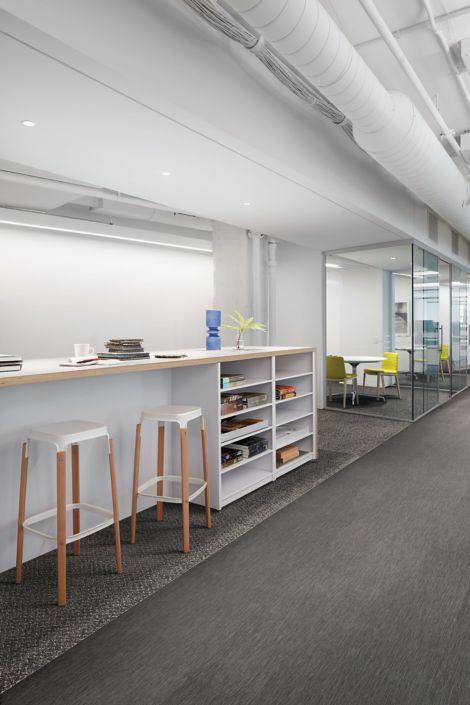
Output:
[[0, 411, 407, 705]]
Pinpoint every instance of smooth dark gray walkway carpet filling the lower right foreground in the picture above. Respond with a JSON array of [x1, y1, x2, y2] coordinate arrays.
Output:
[[2, 393, 470, 705]]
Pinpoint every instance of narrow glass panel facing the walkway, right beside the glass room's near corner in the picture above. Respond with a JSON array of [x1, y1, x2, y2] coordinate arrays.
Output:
[[413, 245, 440, 418]]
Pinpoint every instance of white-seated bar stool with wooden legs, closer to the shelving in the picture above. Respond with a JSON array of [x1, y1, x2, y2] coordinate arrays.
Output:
[[131, 406, 211, 553]]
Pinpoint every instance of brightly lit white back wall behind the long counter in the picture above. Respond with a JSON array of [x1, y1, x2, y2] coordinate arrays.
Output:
[[0, 228, 213, 358]]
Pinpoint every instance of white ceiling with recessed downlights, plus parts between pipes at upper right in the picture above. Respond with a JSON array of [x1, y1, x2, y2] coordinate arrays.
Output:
[[0, 0, 470, 249]]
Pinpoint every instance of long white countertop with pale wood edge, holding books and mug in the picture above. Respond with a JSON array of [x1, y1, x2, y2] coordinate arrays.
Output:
[[0, 347, 316, 388]]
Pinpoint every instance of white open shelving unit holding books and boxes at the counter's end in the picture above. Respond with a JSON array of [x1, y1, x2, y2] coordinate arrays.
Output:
[[172, 352, 317, 509]]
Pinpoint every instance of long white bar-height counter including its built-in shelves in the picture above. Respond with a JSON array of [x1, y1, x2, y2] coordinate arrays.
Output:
[[0, 347, 318, 570]]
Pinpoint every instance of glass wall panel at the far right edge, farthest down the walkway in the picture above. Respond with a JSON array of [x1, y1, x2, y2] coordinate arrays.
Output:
[[451, 265, 467, 394]]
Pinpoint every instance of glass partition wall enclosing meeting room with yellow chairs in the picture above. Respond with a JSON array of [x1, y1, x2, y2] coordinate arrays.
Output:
[[325, 244, 470, 420]]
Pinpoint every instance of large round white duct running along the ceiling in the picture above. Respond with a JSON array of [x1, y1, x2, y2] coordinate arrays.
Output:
[[225, 0, 470, 234]]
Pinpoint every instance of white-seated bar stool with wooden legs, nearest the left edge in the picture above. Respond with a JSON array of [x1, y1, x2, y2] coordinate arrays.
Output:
[[16, 421, 122, 607]]
